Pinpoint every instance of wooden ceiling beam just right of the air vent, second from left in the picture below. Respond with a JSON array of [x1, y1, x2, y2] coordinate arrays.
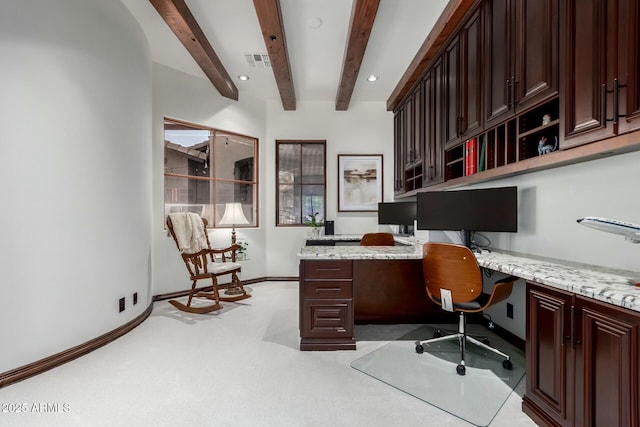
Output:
[[253, 0, 296, 111]]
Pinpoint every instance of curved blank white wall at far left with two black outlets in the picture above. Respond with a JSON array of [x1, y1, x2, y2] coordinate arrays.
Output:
[[0, 0, 151, 372]]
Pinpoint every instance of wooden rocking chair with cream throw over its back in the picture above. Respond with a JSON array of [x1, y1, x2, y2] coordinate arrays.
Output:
[[167, 213, 251, 314]]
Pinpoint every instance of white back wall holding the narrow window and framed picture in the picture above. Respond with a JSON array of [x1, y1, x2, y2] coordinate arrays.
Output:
[[262, 102, 393, 277]]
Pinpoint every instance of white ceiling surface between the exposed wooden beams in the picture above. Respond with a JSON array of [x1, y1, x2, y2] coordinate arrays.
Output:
[[122, 0, 447, 106]]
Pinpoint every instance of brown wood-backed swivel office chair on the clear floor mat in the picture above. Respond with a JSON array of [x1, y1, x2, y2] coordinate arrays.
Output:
[[416, 243, 518, 375]]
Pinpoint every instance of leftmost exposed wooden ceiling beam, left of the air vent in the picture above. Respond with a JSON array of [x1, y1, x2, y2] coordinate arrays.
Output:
[[149, 0, 238, 101]]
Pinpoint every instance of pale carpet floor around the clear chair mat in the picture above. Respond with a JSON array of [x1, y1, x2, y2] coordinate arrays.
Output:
[[0, 282, 534, 427]]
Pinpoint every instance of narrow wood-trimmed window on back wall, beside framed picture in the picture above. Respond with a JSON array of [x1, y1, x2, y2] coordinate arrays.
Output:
[[276, 140, 327, 226]]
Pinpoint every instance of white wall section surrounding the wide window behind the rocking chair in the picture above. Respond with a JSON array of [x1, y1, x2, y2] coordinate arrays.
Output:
[[152, 63, 272, 295]]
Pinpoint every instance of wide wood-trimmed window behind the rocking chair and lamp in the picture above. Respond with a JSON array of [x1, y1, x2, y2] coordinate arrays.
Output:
[[164, 119, 258, 227]]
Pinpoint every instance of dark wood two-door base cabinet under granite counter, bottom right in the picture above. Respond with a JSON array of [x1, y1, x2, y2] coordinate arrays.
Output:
[[522, 283, 640, 427]]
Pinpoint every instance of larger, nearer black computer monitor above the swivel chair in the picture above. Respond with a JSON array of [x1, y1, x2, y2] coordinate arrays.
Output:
[[417, 187, 518, 247]]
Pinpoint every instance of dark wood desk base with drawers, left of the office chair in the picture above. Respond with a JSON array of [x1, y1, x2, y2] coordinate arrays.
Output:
[[300, 259, 450, 350]]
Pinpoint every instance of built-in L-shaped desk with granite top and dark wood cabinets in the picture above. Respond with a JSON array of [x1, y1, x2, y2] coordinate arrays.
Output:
[[298, 244, 640, 426]]
